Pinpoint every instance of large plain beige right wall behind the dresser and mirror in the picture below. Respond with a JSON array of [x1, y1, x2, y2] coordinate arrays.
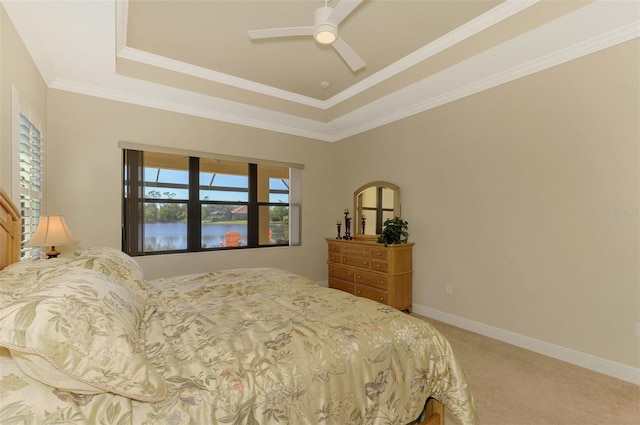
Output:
[[336, 39, 640, 367]]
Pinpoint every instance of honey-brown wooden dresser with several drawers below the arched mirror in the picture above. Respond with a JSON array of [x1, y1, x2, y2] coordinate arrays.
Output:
[[327, 238, 414, 313]]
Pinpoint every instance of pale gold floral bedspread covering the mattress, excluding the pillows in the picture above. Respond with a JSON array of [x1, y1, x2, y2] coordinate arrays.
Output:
[[0, 268, 477, 425]]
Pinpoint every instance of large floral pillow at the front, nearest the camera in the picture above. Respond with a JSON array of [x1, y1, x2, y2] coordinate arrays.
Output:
[[0, 266, 166, 401]]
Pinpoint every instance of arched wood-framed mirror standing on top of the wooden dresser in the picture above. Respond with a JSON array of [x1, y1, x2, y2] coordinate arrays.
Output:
[[353, 181, 400, 238]]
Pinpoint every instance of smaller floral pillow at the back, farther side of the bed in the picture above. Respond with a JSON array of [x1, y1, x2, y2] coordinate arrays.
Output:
[[71, 247, 145, 291]]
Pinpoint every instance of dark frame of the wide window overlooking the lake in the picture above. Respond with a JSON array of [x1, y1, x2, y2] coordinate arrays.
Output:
[[121, 149, 301, 256]]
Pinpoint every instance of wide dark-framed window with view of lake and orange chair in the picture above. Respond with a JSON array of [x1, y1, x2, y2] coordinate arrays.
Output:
[[123, 149, 300, 255]]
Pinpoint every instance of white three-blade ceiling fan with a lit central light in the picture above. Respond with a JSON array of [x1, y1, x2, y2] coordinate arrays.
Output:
[[247, 0, 366, 72]]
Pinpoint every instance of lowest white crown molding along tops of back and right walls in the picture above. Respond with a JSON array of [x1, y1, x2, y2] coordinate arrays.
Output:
[[50, 17, 640, 142]]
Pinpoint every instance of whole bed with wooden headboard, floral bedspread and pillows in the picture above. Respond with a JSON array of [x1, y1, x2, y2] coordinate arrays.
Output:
[[0, 188, 478, 425]]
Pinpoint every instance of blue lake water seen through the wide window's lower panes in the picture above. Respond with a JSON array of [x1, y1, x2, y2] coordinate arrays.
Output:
[[144, 223, 286, 251]]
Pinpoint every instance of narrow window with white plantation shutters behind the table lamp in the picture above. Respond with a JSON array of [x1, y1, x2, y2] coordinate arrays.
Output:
[[13, 88, 44, 259]]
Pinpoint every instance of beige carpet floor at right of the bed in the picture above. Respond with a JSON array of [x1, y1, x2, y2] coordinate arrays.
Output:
[[414, 314, 640, 425]]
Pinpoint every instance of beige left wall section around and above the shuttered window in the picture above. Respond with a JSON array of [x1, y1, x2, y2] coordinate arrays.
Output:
[[0, 6, 47, 195]]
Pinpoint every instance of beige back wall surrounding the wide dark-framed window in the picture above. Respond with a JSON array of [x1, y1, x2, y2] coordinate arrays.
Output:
[[47, 90, 331, 280]]
